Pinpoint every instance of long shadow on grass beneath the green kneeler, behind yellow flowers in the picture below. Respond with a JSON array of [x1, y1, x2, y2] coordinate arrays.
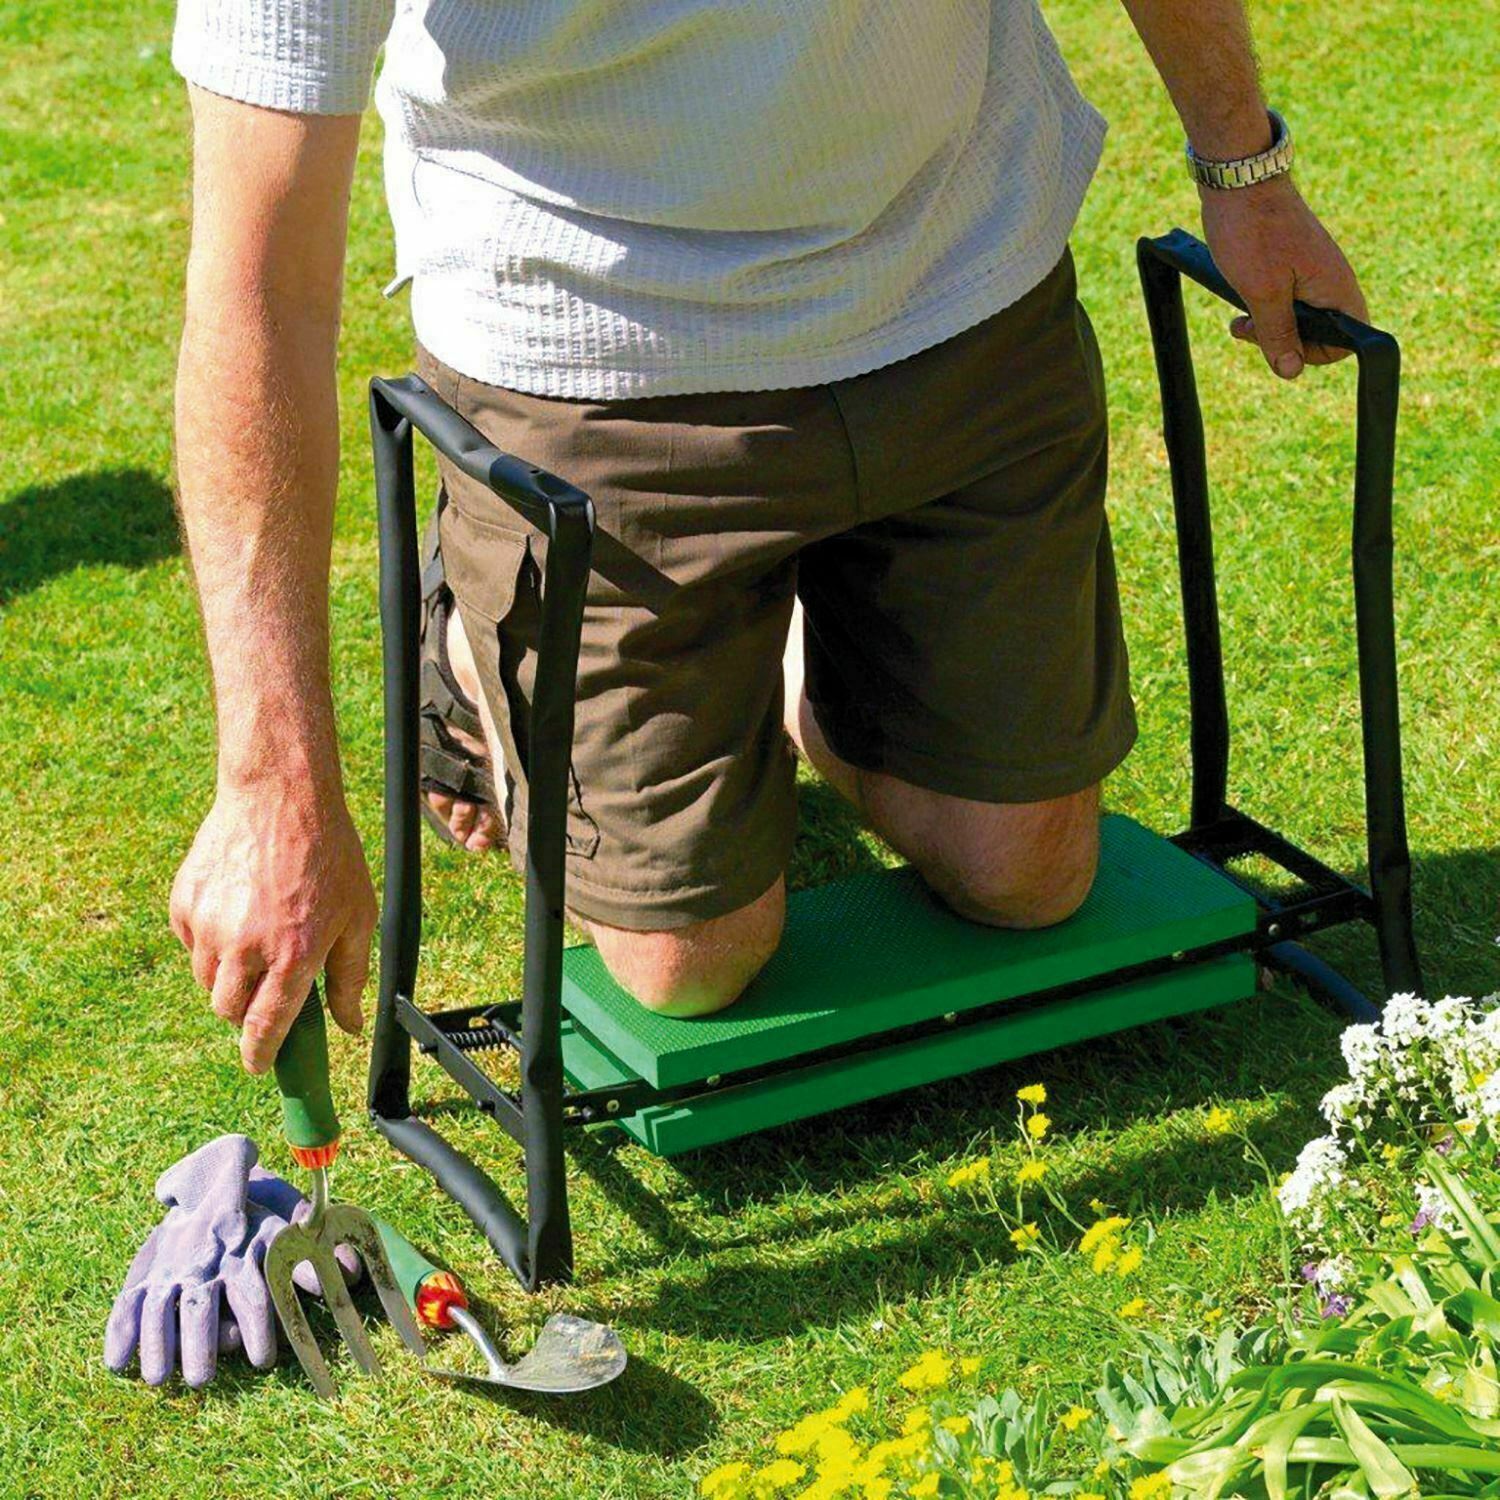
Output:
[[572, 993, 1340, 1314]]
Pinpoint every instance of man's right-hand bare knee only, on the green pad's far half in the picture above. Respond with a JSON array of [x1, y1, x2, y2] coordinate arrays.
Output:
[[920, 791, 1100, 929]]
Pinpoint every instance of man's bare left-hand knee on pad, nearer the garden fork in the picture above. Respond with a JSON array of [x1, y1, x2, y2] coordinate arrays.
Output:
[[587, 879, 786, 1017]]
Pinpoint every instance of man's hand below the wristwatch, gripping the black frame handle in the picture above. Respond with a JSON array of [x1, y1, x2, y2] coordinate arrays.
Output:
[[1202, 177, 1370, 380]]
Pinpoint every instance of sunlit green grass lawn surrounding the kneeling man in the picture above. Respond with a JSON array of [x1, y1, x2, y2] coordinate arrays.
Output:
[[0, 0, 1500, 1500]]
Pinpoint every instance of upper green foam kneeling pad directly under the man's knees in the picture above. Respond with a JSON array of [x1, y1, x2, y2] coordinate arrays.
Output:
[[563, 815, 1256, 1088]]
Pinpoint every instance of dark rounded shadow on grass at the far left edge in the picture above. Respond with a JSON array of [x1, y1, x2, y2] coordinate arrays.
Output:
[[0, 468, 182, 606]]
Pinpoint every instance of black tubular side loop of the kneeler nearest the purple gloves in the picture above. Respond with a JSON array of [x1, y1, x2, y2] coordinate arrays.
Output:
[[369, 375, 594, 1290]]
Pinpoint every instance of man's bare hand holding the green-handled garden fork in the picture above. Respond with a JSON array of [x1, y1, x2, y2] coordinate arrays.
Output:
[[171, 783, 377, 1073]]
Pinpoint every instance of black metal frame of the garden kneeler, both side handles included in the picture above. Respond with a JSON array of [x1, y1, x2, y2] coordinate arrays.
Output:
[[369, 230, 1421, 1290]]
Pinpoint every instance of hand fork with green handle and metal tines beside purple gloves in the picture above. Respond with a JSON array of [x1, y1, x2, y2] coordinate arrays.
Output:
[[266, 986, 426, 1397]]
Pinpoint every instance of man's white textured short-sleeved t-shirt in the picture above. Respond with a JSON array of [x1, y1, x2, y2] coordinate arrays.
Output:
[[173, 0, 1104, 399]]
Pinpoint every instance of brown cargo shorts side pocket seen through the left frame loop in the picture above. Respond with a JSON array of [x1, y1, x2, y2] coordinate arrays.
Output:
[[438, 476, 600, 860]]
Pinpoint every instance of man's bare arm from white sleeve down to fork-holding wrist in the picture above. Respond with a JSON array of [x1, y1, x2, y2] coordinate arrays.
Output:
[[177, 95, 357, 785]]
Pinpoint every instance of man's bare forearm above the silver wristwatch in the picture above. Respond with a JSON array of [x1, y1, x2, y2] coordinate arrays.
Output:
[[1124, 0, 1271, 161]]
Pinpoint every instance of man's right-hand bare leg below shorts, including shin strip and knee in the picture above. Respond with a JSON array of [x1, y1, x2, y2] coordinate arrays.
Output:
[[785, 606, 1100, 927]]
